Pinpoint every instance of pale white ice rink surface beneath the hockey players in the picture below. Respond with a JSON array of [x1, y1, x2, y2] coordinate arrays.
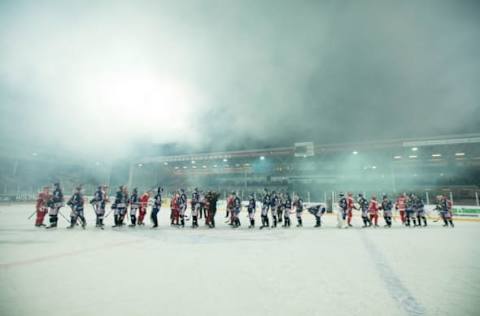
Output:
[[0, 204, 480, 316]]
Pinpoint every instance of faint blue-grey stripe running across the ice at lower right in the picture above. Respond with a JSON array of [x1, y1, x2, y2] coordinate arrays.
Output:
[[361, 234, 425, 316]]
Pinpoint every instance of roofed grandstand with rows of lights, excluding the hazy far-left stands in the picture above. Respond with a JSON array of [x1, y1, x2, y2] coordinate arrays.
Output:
[[128, 134, 480, 205]]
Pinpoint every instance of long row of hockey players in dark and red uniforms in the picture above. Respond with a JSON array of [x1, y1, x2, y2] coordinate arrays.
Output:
[[31, 183, 454, 229]]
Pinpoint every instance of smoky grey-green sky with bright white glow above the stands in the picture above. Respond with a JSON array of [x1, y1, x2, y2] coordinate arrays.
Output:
[[0, 0, 480, 156]]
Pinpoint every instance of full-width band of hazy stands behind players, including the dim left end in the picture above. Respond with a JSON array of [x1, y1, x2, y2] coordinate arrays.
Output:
[[0, 134, 480, 205]]
